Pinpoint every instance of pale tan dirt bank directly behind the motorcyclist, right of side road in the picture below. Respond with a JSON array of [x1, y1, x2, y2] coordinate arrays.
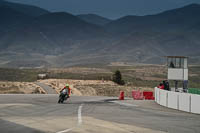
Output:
[[39, 79, 153, 97]]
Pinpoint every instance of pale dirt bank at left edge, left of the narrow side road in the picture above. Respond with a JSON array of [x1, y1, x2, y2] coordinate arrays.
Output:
[[0, 82, 45, 94]]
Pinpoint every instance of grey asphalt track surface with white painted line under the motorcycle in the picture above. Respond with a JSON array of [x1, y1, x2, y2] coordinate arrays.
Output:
[[0, 94, 200, 133]]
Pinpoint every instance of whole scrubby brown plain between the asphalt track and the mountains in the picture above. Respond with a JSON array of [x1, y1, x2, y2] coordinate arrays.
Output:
[[0, 62, 200, 96]]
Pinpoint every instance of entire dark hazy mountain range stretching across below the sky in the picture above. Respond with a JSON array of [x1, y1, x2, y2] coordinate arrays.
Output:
[[0, 1, 200, 67]]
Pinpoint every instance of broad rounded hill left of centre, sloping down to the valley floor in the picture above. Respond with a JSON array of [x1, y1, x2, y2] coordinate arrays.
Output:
[[0, 9, 109, 67]]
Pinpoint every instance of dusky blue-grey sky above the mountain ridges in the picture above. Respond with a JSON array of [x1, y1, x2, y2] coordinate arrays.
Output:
[[9, 0, 200, 18]]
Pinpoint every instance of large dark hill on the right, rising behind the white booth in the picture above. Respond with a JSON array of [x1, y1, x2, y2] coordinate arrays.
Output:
[[105, 4, 200, 63]]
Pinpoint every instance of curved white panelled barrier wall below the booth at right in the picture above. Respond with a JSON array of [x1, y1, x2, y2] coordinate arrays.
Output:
[[155, 87, 200, 114]]
